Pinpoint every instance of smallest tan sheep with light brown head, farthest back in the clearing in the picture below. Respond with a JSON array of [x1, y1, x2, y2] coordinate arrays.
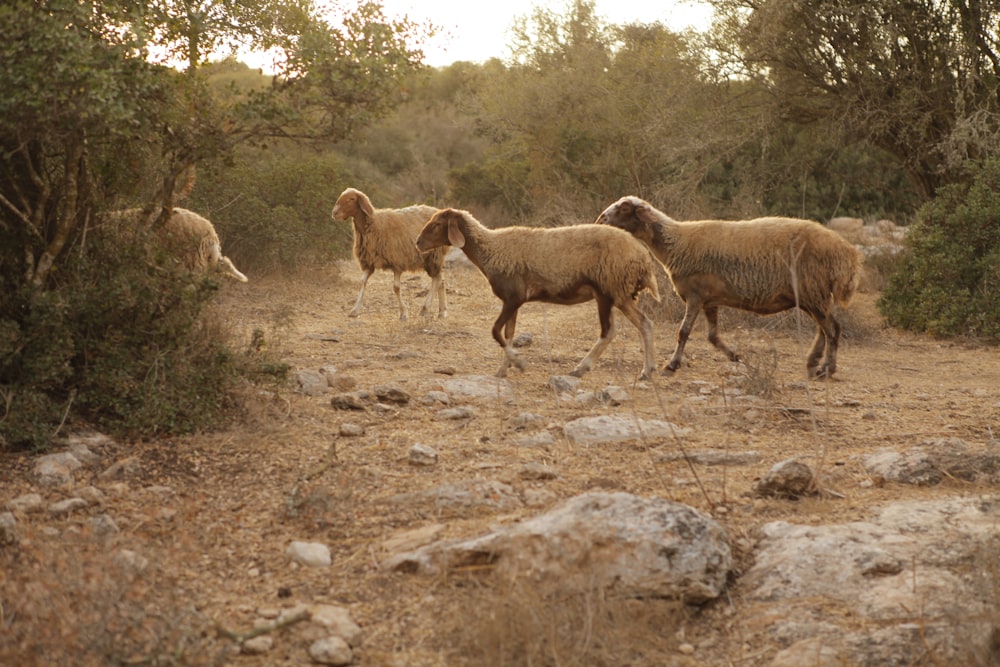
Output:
[[330, 188, 448, 321]]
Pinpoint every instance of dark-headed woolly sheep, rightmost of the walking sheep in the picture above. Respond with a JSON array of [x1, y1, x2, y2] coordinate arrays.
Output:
[[596, 196, 861, 378]]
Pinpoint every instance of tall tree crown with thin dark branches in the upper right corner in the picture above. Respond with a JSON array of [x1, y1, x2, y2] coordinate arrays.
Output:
[[711, 0, 1000, 200]]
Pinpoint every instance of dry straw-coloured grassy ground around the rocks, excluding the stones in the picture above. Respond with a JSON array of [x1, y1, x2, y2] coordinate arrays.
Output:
[[0, 265, 1000, 667]]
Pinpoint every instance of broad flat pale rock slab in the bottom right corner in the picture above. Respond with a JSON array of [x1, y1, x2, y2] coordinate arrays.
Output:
[[739, 494, 1000, 667]]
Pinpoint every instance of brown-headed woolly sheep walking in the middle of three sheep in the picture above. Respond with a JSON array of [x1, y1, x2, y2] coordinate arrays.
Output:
[[417, 209, 660, 379]]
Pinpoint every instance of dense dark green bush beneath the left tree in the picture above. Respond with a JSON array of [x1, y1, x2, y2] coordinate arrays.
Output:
[[0, 227, 270, 450]]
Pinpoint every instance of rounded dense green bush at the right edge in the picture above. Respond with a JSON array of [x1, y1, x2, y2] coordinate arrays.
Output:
[[878, 159, 1000, 342]]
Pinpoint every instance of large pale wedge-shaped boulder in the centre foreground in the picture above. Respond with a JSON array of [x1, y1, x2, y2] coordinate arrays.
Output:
[[385, 493, 732, 603]]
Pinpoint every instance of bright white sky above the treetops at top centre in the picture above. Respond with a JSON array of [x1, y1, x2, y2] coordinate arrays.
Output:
[[381, 0, 712, 67]]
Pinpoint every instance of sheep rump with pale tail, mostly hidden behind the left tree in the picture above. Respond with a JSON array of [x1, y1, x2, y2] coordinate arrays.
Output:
[[98, 207, 248, 283]]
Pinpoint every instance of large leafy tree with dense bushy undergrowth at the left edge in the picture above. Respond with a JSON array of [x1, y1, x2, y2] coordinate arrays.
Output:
[[0, 0, 421, 447]]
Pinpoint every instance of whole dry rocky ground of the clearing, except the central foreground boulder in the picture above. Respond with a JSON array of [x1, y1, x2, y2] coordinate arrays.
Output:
[[0, 254, 1000, 666]]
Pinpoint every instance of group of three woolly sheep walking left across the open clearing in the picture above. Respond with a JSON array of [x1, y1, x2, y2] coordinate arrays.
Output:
[[332, 188, 862, 379]]
